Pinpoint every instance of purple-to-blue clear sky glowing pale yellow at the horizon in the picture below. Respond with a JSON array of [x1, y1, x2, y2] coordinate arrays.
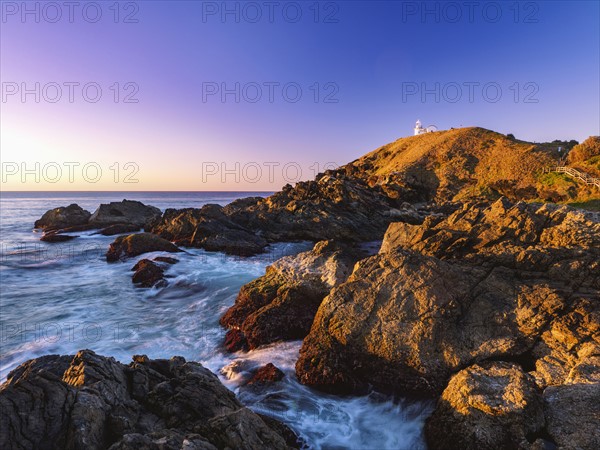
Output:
[[0, 0, 600, 191]]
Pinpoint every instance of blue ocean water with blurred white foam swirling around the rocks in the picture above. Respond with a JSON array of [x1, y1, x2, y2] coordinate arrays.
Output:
[[0, 192, 431, 450]]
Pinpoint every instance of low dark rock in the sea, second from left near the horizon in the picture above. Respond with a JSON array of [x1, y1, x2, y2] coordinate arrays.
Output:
[[89, 200, 162, 228]]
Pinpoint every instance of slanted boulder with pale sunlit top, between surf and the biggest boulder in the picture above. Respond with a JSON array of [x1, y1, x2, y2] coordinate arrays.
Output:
[[221, 241, 361, 351]]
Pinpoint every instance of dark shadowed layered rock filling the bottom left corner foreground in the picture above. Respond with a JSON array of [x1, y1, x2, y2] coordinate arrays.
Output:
[[0, 350, 298, 450]]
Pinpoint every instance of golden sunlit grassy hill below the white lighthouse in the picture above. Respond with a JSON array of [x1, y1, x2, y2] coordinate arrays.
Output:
[[344, 127, 600, 202]]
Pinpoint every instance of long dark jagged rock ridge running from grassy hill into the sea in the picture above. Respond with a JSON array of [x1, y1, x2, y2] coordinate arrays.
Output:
[[146, 174, 423, 256]]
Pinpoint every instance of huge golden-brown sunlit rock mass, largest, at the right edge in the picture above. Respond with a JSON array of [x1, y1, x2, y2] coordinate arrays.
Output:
[[296, 200, 600, 396]]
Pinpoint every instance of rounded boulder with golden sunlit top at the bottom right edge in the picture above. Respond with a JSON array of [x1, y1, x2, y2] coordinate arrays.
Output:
[[425, 362, 544, 450]]
